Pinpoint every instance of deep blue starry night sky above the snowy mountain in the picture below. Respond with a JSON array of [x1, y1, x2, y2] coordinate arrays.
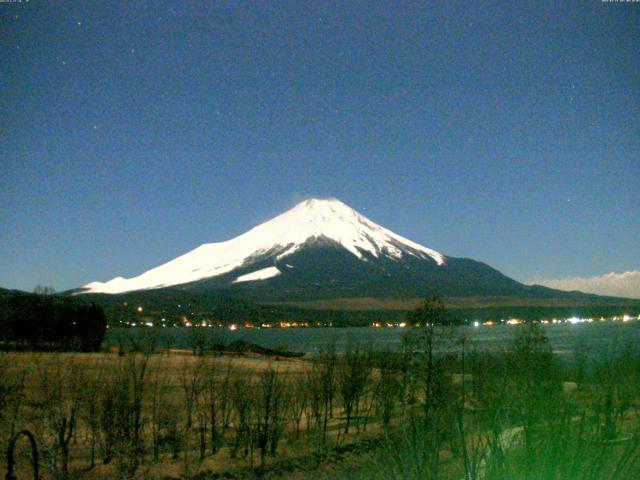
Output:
[[0, 0, 640, 290]]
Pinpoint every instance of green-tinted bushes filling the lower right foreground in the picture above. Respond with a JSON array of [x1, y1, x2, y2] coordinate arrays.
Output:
[[337, 325, 640, 480]]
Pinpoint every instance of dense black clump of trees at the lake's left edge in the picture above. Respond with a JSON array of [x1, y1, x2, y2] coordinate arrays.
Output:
[[0, 292, 107, 352]]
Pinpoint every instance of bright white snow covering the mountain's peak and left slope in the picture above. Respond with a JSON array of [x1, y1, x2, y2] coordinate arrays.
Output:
[[82, 199, 446, 293]]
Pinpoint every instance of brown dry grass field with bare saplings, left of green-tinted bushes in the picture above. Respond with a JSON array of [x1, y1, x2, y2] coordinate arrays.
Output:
[[0, 351, 396, 479]]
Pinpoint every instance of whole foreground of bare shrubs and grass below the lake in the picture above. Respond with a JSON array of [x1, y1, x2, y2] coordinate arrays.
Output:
[[0, 304, 640, 479]]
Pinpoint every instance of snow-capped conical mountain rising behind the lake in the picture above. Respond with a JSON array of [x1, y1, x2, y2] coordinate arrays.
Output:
[[81, 199, 560, 302]]
